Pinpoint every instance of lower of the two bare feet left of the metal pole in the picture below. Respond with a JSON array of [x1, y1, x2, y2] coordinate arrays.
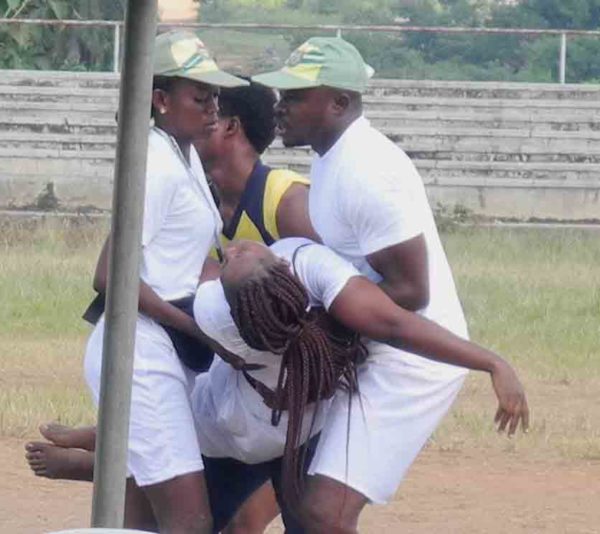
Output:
[[25, 441, 94, 482]]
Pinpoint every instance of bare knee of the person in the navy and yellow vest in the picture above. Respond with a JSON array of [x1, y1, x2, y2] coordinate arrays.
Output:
[[223, 482, 279, 534]]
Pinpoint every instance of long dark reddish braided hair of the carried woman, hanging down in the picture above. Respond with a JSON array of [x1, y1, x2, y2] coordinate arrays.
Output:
[[230, 261, 367, 509]]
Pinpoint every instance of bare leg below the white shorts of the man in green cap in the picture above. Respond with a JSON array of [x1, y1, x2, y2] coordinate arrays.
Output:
[[301, 475, 368, 534]]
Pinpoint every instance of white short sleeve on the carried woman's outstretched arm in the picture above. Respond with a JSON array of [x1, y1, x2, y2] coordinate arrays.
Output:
[[294, 243, 360, 310]]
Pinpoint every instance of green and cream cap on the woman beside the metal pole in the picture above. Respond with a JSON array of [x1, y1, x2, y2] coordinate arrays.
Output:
[[154, 31, 248, 87]]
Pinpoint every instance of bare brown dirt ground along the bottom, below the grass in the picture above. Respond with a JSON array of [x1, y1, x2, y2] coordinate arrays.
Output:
[[0, 439, 600, 534]]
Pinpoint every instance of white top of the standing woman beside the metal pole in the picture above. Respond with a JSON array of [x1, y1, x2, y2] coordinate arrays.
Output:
[[140, 128, 221, 300]]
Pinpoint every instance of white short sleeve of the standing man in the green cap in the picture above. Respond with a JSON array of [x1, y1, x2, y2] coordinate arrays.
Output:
[[341, 156, 425, 256]]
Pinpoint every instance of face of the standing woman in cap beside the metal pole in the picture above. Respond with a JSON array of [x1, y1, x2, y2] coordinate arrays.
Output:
[[153, 78, 219, 141]]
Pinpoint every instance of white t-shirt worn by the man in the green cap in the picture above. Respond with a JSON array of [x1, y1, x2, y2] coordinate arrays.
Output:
[[309, 117, 467, 373]]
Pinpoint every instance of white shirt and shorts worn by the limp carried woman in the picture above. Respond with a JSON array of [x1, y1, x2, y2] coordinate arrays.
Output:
[[192, 238, 359, 464]]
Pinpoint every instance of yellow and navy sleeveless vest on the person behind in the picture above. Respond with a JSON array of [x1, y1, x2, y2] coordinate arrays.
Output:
[[223, 160, 310, 245]]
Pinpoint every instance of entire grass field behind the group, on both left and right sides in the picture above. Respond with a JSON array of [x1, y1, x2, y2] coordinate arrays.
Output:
[[0, 220, 600, 460]]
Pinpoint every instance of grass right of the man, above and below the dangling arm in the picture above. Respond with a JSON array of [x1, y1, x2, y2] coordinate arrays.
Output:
[[435, 228, 600, 459]]
